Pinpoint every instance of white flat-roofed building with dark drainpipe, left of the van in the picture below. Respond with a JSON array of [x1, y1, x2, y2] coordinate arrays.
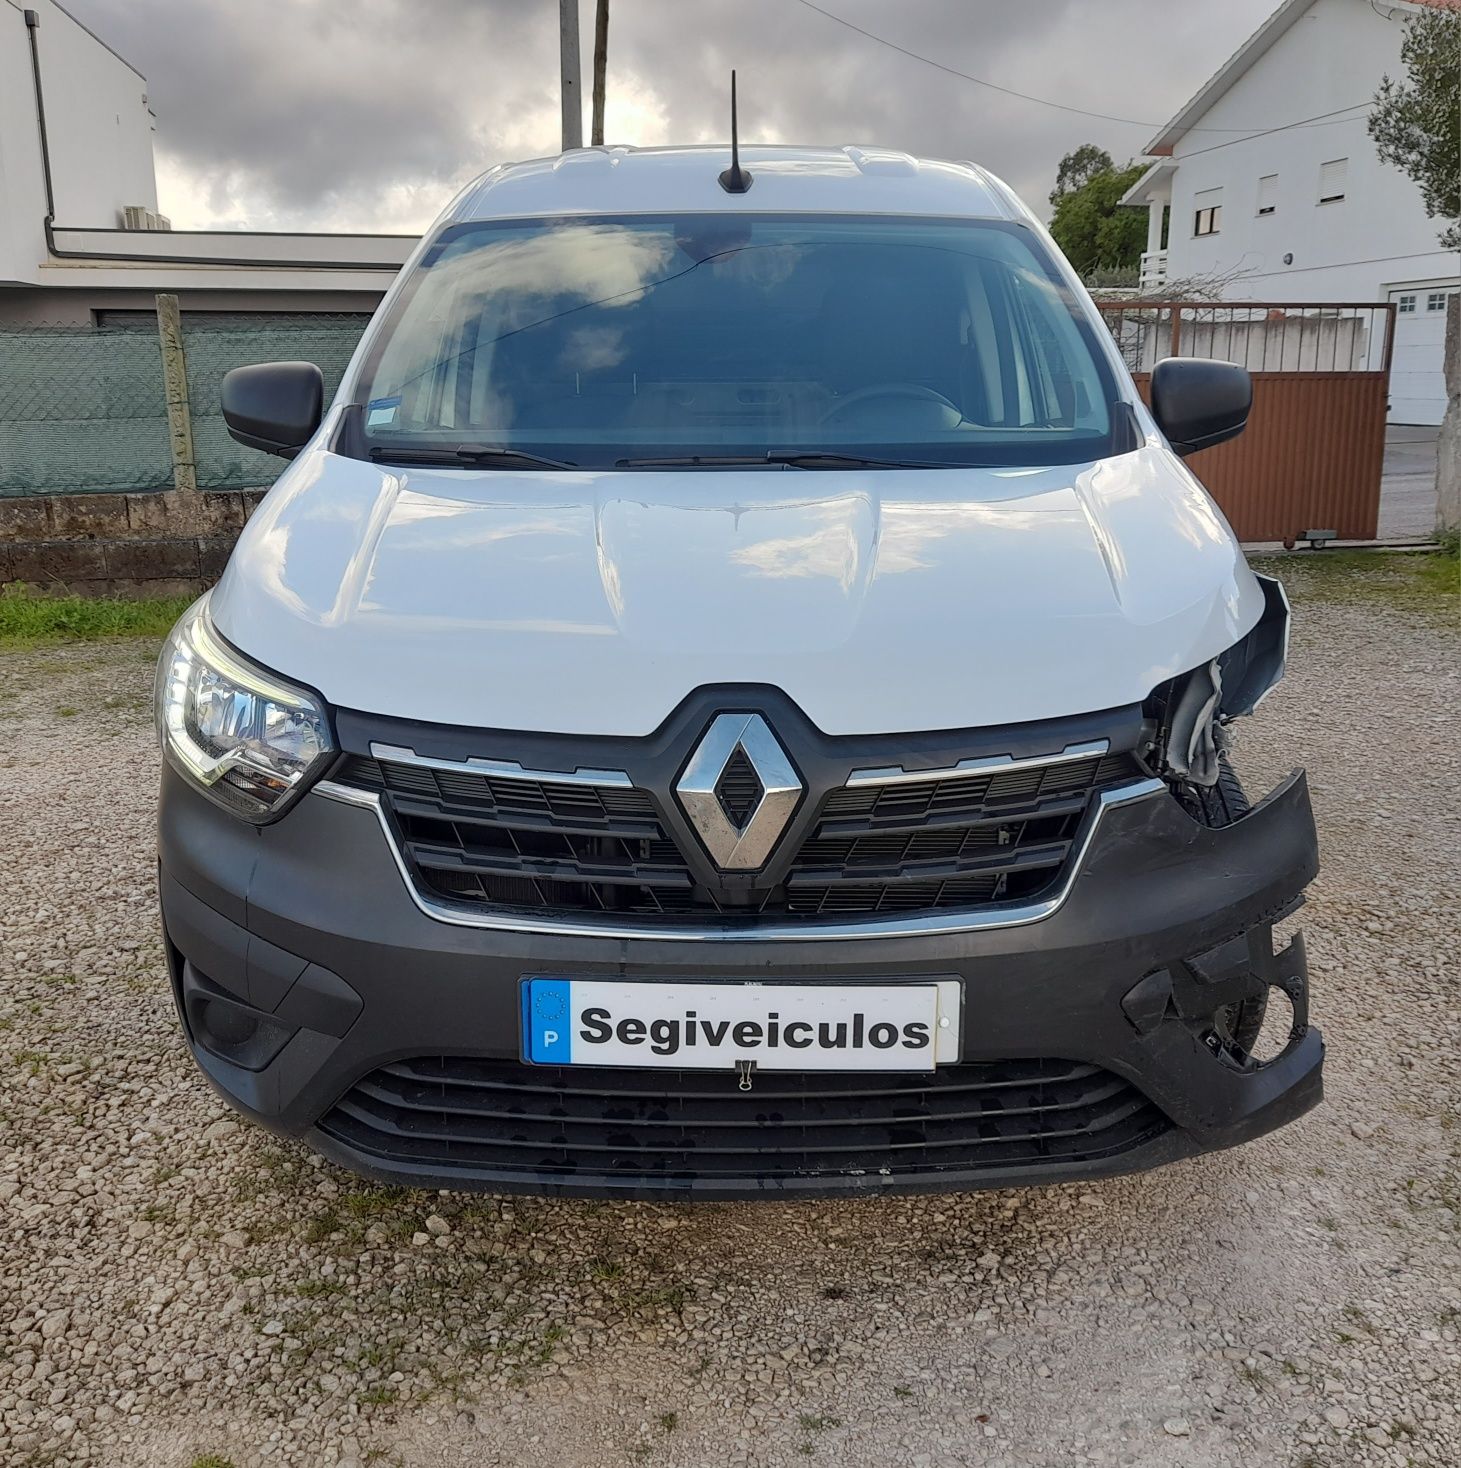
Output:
[[0, 0, 414, 326]]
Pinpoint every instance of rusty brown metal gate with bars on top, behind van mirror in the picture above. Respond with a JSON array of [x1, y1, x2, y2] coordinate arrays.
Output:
[[1100, 301, 1395, 540]]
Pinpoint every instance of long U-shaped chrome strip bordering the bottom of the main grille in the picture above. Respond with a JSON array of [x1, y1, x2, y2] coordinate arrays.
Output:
[[314, 775, 1167, 944]]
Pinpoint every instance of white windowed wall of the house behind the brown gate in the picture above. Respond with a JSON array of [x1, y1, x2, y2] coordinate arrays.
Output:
[[1167, 0, 1461, 301]]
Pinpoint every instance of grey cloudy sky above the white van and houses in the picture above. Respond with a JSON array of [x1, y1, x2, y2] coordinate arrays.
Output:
[[66, 0, 1276, 230]]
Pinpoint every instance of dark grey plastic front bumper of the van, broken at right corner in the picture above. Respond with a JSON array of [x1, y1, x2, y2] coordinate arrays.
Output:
[[160, 769, 1323, 1198]]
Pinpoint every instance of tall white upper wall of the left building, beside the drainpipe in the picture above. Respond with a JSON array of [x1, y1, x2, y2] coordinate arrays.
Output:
[[0, 0, 157, 280]]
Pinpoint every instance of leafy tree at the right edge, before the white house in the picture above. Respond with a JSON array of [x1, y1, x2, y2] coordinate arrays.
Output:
[[1370, 10, 1461, 250]]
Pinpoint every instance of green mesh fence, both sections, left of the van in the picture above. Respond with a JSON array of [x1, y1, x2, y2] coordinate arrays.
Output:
[[0, 311, 370, 496]]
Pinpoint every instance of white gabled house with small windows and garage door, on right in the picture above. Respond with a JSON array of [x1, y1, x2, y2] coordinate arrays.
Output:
[[1125, 0, 1461, 424]]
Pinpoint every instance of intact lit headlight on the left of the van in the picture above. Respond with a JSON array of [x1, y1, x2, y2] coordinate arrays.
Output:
[[156, 597, 335, 822]]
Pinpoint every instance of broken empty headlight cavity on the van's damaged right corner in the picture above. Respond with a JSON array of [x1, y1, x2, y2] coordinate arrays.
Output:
[[1147, 575, 1289, 790]]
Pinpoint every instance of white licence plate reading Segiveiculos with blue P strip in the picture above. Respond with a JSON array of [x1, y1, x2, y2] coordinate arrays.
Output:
[[523, 976, 960, 1070]]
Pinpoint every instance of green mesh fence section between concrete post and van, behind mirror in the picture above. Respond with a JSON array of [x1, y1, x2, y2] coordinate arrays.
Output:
[[182, 313, 370, 489]]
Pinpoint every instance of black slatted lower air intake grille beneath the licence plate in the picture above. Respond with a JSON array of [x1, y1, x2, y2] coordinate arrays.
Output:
[[320, 1057, 1169, 1186]]
